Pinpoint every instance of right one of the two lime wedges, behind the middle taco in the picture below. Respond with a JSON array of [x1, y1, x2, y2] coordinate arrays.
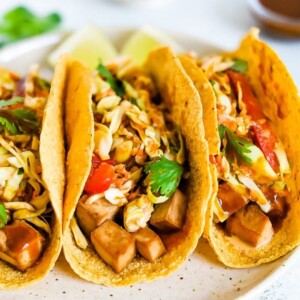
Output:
[[121, 26, 183, 65]]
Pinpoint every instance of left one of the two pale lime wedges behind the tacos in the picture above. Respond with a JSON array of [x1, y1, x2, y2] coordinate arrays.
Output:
[[48, 25, 118, 69]]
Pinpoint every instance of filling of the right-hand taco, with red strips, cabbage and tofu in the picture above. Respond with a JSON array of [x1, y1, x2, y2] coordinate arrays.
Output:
[[197, 56, 290, 248]]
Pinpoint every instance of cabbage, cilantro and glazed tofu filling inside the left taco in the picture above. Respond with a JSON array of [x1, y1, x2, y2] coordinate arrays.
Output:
[[0, 67, 52, 271]]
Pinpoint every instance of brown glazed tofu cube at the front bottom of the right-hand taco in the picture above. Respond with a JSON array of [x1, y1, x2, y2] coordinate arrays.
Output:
[[226, 204, 274, 247]]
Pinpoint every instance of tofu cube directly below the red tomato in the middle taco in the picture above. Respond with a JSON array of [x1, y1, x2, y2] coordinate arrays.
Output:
[[76, 198, 120, 235]]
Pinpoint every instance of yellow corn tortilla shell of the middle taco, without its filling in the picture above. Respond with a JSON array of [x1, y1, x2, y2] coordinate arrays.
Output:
[[63, 48, 211, 286]]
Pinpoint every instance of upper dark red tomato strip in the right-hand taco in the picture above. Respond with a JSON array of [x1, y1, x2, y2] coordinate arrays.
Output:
[[226, 70, 265, 121]]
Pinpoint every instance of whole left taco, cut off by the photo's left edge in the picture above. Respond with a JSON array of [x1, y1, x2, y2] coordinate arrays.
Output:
[[0, 59, 66, 289]]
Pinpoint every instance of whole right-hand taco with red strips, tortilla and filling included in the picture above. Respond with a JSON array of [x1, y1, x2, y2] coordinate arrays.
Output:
[[181, 29, 300, 268]]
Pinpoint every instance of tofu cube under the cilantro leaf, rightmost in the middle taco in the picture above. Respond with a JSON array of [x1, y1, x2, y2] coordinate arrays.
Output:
[[150, 189, 187, 231]]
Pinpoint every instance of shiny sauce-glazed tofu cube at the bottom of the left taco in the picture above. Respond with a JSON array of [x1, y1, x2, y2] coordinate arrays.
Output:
[[0, 221, 45, 271]]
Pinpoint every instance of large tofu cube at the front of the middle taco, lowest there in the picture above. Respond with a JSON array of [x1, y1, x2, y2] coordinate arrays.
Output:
[[91, 220, 136, 273]]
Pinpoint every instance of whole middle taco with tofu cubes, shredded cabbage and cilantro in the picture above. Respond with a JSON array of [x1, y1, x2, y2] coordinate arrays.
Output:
[[63, 48, 211, 286]]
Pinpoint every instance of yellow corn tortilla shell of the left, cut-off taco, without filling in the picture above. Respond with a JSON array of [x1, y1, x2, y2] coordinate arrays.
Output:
[[0, 57, 67, 289]]
